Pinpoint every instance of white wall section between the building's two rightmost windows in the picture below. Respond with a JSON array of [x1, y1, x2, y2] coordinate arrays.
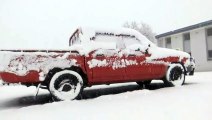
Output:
[[190, 28, 212, 71]]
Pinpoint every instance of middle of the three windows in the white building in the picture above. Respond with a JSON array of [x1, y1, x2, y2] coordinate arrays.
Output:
[[183, 33, 191, 54]]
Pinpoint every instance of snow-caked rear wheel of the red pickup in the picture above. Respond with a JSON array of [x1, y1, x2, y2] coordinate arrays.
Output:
[[49, 70, 83, 101]]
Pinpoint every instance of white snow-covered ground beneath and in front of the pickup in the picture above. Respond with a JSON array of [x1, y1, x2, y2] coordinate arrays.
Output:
[[0, 72, 212, 120]]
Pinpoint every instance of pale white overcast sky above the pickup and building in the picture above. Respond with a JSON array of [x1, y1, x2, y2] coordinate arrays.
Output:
[[0, 0, 212, 48]]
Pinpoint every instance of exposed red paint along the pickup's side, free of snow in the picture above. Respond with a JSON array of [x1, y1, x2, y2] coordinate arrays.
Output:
[[0, 48, 185, 85]]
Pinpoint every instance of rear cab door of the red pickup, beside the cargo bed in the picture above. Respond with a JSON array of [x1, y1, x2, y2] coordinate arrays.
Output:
[[86, 49, 125, 84]]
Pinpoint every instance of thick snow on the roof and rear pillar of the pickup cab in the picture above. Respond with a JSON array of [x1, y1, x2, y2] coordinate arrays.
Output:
[[69, 27, 155, 54]]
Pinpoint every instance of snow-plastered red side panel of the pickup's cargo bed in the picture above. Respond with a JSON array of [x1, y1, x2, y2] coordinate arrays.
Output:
[[0, 51, 86, 83]]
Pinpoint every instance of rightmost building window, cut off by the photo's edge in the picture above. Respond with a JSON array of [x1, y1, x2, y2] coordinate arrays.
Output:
[[207, 28, 212, 59]]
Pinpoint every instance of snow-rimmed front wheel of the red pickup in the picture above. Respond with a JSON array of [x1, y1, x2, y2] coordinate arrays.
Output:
[[164, 64, 185, 86]]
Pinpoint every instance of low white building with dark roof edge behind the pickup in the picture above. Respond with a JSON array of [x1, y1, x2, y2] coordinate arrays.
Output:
[[156, 20, 212, 71]]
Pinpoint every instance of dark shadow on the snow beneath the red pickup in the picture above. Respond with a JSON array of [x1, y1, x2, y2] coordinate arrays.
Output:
[[0, 83, 196, 110]]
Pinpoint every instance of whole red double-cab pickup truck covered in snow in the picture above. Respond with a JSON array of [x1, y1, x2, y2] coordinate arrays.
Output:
[[0, 28, 194, 100]]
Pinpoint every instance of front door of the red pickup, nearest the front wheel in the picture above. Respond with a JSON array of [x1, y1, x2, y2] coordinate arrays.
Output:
[[124, 47, 166, 81]]
